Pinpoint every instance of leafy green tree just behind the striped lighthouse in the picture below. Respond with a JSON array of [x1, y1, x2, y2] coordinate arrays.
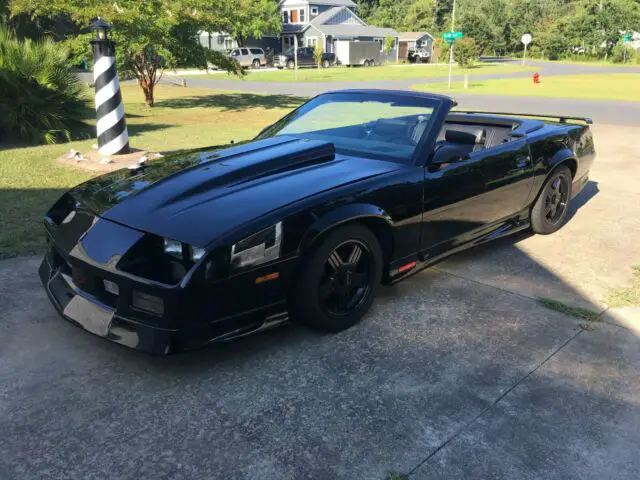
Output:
[[9, 0, 280, 106]]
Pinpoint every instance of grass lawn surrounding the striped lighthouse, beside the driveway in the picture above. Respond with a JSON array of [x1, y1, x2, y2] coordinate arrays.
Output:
[[0, 85, 303, 259]]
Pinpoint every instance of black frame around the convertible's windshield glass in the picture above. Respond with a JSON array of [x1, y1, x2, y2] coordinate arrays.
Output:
[[254, 90, 456, 165]]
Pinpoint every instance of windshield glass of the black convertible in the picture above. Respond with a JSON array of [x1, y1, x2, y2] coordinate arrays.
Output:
[[258, 93, 437, 162]]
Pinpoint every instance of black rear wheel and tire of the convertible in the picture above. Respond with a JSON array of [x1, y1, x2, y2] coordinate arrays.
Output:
[[531, 166, 573, 235]]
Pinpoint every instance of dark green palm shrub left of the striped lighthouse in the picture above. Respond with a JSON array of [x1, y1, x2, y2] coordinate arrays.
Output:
[[0, 25, 87, 143]]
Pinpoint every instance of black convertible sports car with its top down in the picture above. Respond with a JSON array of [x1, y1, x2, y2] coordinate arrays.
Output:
[[40, 90, 595, 355]]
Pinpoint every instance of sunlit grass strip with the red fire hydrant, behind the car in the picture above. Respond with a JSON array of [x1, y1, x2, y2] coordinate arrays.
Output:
[[413, 73, 640, 102]]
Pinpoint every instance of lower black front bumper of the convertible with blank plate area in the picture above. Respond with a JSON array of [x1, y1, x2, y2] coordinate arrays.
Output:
[[38, 245, 286, 356]]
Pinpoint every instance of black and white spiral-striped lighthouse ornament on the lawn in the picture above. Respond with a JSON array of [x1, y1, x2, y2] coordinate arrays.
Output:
[[91, 17, 129, 155]]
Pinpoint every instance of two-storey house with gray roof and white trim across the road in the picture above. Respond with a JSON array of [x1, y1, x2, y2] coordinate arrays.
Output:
[[279, 0, 398, 61]]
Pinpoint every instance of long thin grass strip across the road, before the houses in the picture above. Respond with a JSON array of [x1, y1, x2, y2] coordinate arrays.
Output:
[[186, 64, 532, 82]]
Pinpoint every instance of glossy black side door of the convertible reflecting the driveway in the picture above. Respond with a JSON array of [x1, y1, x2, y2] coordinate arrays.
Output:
[[420, 138, 533, 256]]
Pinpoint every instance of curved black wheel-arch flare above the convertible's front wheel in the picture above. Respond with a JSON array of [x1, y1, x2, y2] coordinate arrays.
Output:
[[299, 203, 393, 252]]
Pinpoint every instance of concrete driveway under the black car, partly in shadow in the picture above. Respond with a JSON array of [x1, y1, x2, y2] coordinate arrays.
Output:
[[0, 126, 640, 480]]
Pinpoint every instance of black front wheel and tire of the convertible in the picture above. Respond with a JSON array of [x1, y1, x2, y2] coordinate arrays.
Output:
[[290, 224, 383, 333]]
